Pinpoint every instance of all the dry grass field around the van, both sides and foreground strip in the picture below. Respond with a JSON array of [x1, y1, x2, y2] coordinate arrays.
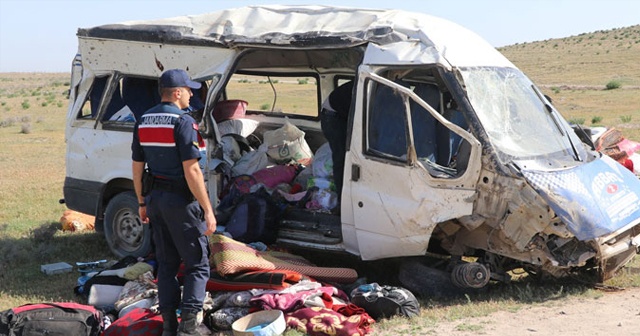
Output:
[[0, 26, 640, 335]]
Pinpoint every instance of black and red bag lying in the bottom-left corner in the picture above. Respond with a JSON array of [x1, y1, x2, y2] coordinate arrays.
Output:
[[0, 302, 103, 336]]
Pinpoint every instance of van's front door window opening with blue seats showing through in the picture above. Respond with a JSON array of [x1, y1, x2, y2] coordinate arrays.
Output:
[[367, 71, 468, 178]]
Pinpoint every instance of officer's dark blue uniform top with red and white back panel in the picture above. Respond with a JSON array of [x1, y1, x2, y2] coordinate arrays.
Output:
[[131, 103, 200, 179]]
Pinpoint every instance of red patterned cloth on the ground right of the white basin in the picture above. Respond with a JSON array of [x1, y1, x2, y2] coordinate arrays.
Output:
[[285, 307, 375, 336]]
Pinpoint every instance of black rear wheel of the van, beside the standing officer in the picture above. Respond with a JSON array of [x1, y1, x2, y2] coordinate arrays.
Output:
[[104, 191, 152, 258]]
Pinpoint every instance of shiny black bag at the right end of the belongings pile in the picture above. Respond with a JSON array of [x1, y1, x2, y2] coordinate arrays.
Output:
[[351, 282, 420, 320]]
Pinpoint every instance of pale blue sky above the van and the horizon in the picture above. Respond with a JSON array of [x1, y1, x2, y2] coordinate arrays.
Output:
[[0, 0, 640, 72]]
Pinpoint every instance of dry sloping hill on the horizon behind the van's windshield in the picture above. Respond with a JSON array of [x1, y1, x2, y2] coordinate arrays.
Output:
[[498, 25, 640, 87]]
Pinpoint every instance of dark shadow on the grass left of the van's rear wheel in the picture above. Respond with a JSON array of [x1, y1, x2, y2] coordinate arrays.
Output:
[[0, 222, 114, 310]]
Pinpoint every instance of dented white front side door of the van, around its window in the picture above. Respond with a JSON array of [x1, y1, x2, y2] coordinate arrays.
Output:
[[342, 67, 481, 260]]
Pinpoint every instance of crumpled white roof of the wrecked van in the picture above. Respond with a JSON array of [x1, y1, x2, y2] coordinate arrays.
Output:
[[77, 5, 513, 67]]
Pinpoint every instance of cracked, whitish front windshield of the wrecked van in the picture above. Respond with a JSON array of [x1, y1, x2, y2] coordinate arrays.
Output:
[[460, 67, 580, 163]]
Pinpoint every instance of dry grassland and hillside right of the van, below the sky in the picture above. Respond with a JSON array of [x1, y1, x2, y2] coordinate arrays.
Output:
[[499, 25, 640, 141]]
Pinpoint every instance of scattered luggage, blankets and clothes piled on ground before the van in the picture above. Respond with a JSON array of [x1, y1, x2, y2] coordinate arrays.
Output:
[[0, 234, 420, 336]]
